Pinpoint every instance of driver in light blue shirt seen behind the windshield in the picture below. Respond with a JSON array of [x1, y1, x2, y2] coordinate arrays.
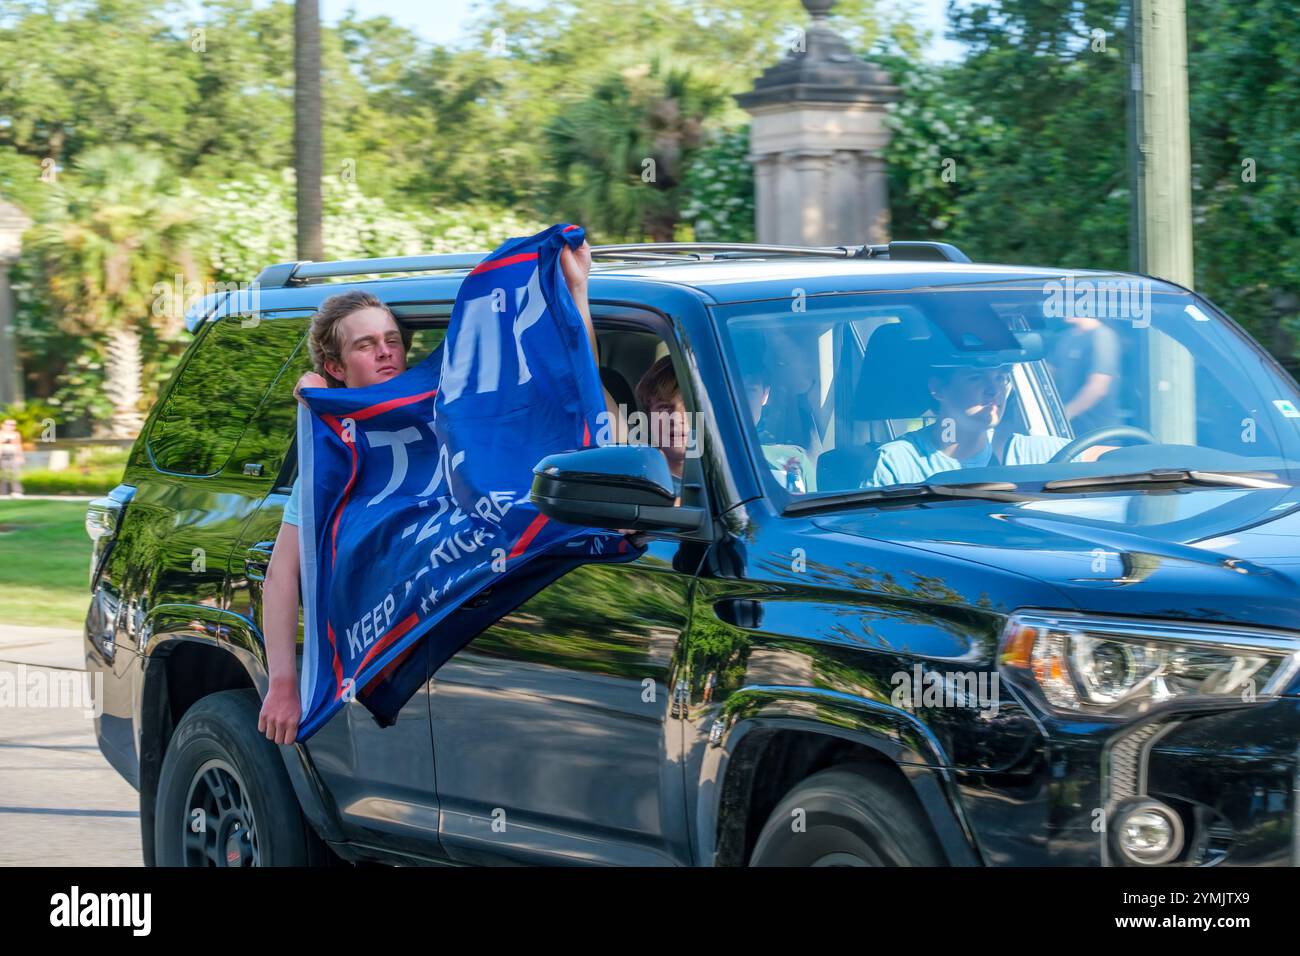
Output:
[[863, 365, 1113, 488]]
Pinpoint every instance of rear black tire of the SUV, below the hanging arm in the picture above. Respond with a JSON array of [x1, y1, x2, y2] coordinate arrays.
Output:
[[153, 688, 328, 866]]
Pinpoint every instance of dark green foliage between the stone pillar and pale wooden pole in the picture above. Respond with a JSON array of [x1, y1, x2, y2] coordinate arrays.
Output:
[[896, 0, 1130, 269]]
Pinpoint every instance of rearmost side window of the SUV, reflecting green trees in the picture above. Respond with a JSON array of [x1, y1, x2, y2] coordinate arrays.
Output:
[[150, 316, 303, 475]]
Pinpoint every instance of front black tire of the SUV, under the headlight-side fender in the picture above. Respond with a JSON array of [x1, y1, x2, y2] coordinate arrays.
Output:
[[749, 763, 946, 866]]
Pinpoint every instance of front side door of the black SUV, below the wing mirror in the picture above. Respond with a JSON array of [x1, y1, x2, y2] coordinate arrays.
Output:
[[429, 313, 705, 865]]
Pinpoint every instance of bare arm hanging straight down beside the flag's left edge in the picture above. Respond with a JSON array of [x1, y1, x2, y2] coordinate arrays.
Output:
[[257, 523, 302, 744]]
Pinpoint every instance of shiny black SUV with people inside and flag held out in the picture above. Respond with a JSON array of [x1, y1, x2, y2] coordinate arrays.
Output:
[[94, 243, 1300, 866]]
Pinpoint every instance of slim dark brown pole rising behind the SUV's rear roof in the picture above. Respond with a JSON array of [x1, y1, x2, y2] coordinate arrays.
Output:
[[294, 0, 325, 261]]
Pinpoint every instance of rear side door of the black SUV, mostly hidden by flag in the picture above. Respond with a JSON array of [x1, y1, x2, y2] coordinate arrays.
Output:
[[229, 319, 441, 857]]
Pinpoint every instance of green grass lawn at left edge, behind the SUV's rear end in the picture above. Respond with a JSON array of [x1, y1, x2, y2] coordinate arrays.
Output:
[[0, 498, 90, 627]]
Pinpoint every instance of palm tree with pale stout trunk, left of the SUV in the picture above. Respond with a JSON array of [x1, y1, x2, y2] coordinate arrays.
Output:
[[34, 146, 198, 438]]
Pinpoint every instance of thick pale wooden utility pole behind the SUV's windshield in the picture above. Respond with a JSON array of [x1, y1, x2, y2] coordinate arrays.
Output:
[[1128, 0, 1193, 289]]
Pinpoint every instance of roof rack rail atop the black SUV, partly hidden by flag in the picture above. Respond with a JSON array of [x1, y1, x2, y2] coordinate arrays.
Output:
[[254, 242, 970, 289]]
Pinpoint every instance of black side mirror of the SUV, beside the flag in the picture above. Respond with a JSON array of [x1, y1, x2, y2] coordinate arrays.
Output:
[[528, 445, 705, 531]]
